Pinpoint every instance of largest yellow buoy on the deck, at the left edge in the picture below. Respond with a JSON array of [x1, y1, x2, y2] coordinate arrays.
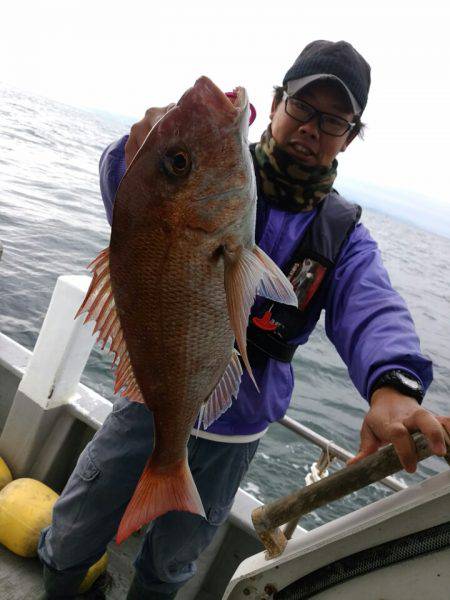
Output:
[[0, 478, 58, 557]]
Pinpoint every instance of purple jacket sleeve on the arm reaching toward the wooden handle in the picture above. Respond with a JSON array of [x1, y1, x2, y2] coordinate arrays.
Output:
[[325, 224, 433, 400]]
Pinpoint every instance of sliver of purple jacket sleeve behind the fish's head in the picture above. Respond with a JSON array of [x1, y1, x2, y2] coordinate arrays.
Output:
[[99, 135, 128, 225]]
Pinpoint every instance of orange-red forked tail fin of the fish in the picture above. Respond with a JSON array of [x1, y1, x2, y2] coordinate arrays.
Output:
[[116, 458, 205, 544]]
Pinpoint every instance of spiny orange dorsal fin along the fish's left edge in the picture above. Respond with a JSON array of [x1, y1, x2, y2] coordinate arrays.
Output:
[[75, 248, 144, 402]]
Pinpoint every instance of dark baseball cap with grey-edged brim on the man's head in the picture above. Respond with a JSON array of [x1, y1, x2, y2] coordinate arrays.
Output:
[[283, 40, 370, 115]]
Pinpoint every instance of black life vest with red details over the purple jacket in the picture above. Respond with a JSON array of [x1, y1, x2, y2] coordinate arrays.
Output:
[[247, 146, 362, 363]]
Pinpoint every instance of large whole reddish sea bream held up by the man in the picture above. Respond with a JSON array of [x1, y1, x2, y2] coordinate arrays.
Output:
[[75, 77, 297, 542]]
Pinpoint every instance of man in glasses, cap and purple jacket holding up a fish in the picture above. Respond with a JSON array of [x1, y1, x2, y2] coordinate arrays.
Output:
[[39, 41, 450, 600]]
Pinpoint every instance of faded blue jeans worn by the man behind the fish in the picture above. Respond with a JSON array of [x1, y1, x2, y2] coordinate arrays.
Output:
[[38, 398, 258, 593]]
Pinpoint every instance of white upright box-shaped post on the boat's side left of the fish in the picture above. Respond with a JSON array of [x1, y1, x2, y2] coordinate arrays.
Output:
[[19, 275, 95, 409]]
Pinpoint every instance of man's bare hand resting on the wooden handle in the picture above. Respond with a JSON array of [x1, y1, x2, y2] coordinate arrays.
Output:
[[347, 387, 450, 473]]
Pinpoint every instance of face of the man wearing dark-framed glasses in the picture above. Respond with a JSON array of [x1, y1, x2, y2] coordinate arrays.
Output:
[[270, 81, 355, 167]]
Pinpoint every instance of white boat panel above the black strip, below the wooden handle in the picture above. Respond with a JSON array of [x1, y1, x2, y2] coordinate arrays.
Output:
[[223, 470, 450, 600]]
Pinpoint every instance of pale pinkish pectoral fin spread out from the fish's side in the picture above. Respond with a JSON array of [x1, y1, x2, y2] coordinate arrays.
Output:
[[225, 246, 298, 389]]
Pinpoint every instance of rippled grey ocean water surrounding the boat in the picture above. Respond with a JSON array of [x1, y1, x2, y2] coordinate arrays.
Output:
[[0, 85, 450, 528]]
